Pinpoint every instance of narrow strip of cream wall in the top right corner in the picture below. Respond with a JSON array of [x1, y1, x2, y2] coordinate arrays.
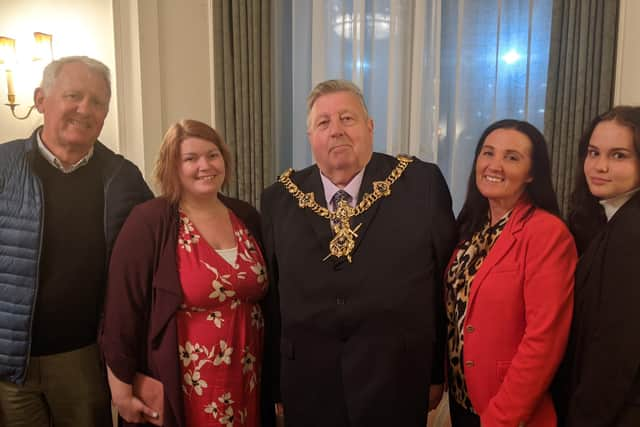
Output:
[[614, 0, 640, 105]]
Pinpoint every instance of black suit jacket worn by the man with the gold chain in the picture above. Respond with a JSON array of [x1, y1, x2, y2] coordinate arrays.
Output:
[[261, 153, 455, 427]]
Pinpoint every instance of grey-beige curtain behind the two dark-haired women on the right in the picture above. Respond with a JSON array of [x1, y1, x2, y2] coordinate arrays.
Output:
[[544, 0, 619, 216]]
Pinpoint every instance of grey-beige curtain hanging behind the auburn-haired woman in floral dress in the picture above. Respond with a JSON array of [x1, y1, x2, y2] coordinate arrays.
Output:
[[213, 0, 275, 206]]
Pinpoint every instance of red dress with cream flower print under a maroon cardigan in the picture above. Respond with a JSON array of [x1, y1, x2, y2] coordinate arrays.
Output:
[[177, 211, 267, 427]]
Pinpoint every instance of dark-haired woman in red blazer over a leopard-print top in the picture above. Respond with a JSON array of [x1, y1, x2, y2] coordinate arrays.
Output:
[[446, 120, 576, 427]]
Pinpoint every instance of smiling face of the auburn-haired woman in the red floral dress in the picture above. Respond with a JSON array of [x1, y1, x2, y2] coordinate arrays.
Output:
[[178, 137, 226, 203]]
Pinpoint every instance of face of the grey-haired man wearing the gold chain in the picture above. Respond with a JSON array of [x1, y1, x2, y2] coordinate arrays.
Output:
[[307, 91, 373, 185]]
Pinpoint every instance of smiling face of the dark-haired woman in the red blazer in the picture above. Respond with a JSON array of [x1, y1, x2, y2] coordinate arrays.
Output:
[[475, 129, 533, 214]]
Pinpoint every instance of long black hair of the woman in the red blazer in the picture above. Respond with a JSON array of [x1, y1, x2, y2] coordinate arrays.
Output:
[[457, 119, 560, 240]]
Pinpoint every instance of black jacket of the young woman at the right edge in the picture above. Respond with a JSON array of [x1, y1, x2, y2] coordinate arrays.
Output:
[[557, 193, 640, 427]]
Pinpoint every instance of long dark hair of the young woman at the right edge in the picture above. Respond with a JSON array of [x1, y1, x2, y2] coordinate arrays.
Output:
[[569, 105, 640, 253]]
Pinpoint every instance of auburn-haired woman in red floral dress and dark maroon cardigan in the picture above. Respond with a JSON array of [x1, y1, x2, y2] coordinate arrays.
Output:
[[100, 120, 267, 427]]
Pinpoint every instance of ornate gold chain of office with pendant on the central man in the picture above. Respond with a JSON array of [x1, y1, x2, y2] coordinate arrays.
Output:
[[278, 155, 413, 262]]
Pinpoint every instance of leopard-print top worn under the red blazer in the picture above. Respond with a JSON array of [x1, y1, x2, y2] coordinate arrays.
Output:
[[446, 212, 511, 413]]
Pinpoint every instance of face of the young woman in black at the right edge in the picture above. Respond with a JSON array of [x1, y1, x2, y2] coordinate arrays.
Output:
[[584, 120, 640, 199]]
